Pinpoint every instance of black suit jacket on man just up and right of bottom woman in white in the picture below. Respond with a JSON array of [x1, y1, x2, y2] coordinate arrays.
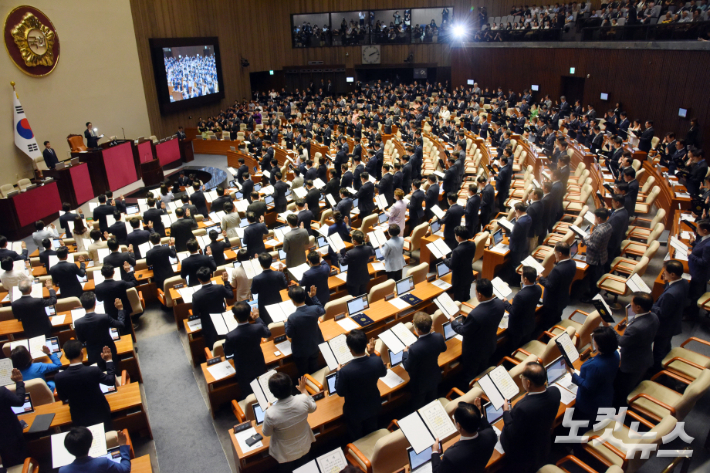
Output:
[[335, 354, 387, 419]]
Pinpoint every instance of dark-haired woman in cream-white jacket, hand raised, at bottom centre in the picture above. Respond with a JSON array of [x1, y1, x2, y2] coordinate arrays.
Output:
[[262, 373, 316, 472]]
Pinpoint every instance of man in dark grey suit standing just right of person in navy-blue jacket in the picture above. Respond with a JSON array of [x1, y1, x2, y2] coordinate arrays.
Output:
[[602, 292, 660, 408]]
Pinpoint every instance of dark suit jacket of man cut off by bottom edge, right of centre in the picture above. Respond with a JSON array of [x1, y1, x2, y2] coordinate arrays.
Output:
[[431, 415, 498, 473]]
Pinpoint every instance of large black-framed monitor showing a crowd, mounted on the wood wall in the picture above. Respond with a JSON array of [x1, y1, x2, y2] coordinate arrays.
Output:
[[149, 37, 224, 113]]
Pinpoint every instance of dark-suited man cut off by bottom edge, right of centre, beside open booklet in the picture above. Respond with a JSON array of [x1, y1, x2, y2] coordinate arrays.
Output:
[[431, 397, 498, 473]]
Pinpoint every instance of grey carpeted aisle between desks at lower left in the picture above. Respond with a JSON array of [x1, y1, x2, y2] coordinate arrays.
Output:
[[140, 331, 231, 473]]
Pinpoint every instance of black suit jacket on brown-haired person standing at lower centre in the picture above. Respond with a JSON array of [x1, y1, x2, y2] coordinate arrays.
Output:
[[402, 332, 446, 396]]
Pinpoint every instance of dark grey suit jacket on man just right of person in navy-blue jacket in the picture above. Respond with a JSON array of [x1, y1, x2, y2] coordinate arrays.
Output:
[[616, 312, 660, 373]]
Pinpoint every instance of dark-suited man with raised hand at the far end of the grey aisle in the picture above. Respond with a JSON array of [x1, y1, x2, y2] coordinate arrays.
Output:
[[192, 266, 234, 350]]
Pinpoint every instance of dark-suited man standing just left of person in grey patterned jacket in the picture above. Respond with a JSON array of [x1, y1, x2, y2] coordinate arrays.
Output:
[[539, 242, 577, 330]]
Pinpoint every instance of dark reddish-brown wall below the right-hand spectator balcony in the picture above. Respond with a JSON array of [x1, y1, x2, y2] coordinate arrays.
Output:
[[451, 47, 710, 148]]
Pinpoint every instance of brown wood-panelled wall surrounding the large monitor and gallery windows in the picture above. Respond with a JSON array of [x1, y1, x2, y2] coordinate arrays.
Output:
[[130, 0, 601, 137]]
